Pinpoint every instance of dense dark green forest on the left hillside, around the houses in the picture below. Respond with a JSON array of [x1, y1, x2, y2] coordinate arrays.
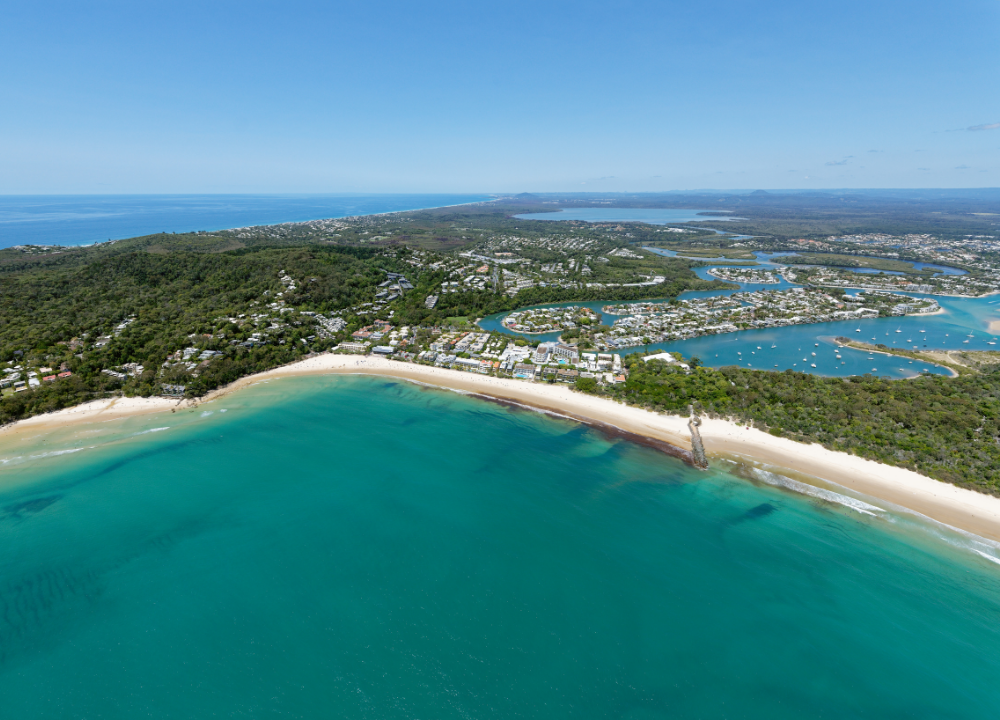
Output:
[[0, 246, 422, 423]]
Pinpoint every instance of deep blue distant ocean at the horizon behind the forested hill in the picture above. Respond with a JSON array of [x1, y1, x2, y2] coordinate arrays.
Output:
[[0, 195, 490, 248]]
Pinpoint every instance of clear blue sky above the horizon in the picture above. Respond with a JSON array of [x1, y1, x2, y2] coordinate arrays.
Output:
[[0, 0, 1000, 194]]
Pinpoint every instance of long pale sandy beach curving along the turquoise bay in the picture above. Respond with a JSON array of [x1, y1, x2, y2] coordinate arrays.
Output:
[[0, 354, 1000, 541]]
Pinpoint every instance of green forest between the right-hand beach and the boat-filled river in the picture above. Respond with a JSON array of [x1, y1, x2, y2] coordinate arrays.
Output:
[[579, 356, 1000, 495]]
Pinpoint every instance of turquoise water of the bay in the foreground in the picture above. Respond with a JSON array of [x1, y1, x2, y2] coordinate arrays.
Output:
[[0, 377, 1000, 719]]
